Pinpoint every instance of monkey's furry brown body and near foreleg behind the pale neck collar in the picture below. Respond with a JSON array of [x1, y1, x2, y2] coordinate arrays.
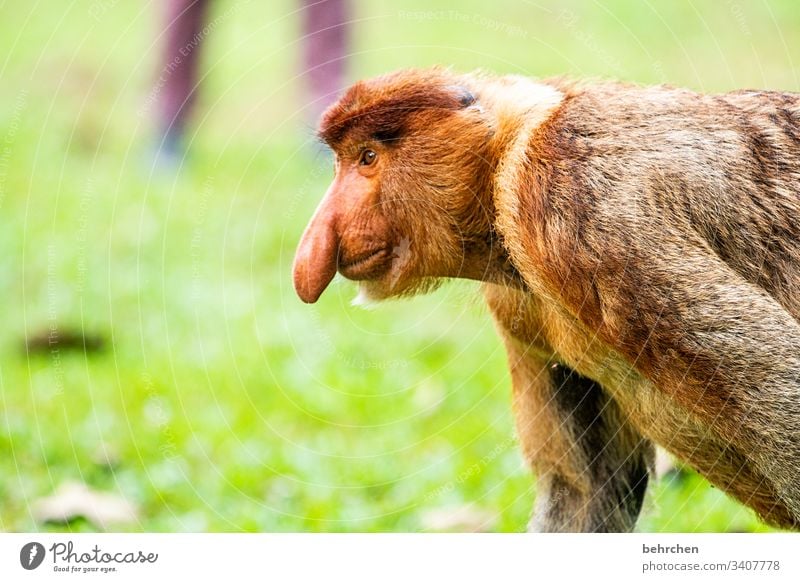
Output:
[[495, 81, 800, 527]]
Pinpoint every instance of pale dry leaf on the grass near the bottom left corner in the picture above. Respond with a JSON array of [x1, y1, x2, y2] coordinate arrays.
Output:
[[33, 482, 139, 529]]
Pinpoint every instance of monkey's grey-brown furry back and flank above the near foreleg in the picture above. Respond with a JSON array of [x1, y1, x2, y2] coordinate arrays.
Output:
[[536, 82, 800, 321]]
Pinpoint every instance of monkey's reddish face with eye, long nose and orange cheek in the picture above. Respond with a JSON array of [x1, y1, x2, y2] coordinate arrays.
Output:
[[294, 143, 456, 303]]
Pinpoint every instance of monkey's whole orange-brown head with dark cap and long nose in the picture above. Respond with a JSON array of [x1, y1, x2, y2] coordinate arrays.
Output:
[[294, 69, 500, 303]]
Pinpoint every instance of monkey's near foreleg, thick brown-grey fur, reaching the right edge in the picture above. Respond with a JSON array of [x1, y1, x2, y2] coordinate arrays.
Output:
[[584, 242, 800, 529]]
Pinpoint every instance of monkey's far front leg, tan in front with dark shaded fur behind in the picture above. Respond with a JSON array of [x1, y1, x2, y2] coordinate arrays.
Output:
[[506, 338, 653, 532]]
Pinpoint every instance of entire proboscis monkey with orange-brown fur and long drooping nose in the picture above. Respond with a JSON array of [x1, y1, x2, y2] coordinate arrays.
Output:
[[294, 69, 800, 531]]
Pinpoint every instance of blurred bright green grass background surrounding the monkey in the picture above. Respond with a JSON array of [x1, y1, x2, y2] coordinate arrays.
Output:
[[0, 0, 800, 531]]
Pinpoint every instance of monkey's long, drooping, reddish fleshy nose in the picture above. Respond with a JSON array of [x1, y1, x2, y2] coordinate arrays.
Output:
[[294, 207, 339, 303]]
